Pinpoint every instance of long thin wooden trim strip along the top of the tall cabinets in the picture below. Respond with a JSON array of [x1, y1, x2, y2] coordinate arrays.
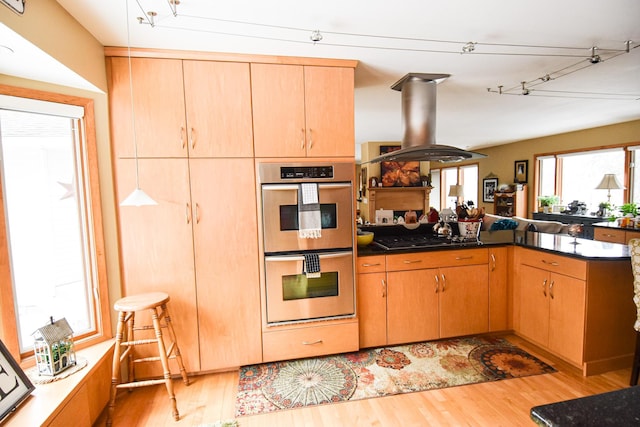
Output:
[[104, 46, 358, 68]]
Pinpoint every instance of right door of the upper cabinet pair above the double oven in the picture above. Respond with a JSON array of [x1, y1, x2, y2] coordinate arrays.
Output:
[[304, 67, 355, 157]]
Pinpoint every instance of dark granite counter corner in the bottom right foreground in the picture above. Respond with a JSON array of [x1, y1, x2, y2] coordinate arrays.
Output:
[[531, 386, 640, 427]]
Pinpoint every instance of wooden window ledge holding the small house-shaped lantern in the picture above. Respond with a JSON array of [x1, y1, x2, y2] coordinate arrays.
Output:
[[3, 340, 114, 427]]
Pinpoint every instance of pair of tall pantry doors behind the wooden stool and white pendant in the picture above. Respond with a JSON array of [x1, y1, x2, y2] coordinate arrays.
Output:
[[112, 159, 261, 376]]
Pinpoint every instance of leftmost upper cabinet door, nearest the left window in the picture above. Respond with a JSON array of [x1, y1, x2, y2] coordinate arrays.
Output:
[[108, 57, 187, 158]]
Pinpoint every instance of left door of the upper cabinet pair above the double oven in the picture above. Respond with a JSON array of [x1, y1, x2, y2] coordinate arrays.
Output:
[[251, 64, 306, 157]]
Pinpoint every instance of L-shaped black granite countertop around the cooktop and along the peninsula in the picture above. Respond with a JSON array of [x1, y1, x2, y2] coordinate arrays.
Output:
[[358, 225, 629, 261]]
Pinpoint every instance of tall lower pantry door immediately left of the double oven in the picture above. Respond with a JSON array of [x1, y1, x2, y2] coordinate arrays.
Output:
[[189, 159, 262, 371]]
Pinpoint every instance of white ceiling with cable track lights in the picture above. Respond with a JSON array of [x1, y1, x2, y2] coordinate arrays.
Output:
[[0, 0, 640, 160]]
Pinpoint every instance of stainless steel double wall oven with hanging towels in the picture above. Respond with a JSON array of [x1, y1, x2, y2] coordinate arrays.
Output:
[[258, 162, 355, 324]]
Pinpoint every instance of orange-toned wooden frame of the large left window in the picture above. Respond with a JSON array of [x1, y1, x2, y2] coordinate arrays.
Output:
[[0, 84, 112, 364]]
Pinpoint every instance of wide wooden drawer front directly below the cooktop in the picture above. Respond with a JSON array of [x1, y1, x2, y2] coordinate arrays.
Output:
[[387, 249, 489, 271]]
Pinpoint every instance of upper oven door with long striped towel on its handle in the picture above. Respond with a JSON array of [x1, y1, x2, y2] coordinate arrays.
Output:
[[262, 182, 354, 252]]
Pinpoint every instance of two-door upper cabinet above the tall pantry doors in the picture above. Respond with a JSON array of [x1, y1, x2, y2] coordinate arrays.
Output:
[[107, 57, 253, 158]]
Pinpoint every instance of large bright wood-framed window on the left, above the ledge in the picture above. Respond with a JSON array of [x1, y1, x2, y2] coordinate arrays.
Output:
[[0, 85, 110, 357]]
